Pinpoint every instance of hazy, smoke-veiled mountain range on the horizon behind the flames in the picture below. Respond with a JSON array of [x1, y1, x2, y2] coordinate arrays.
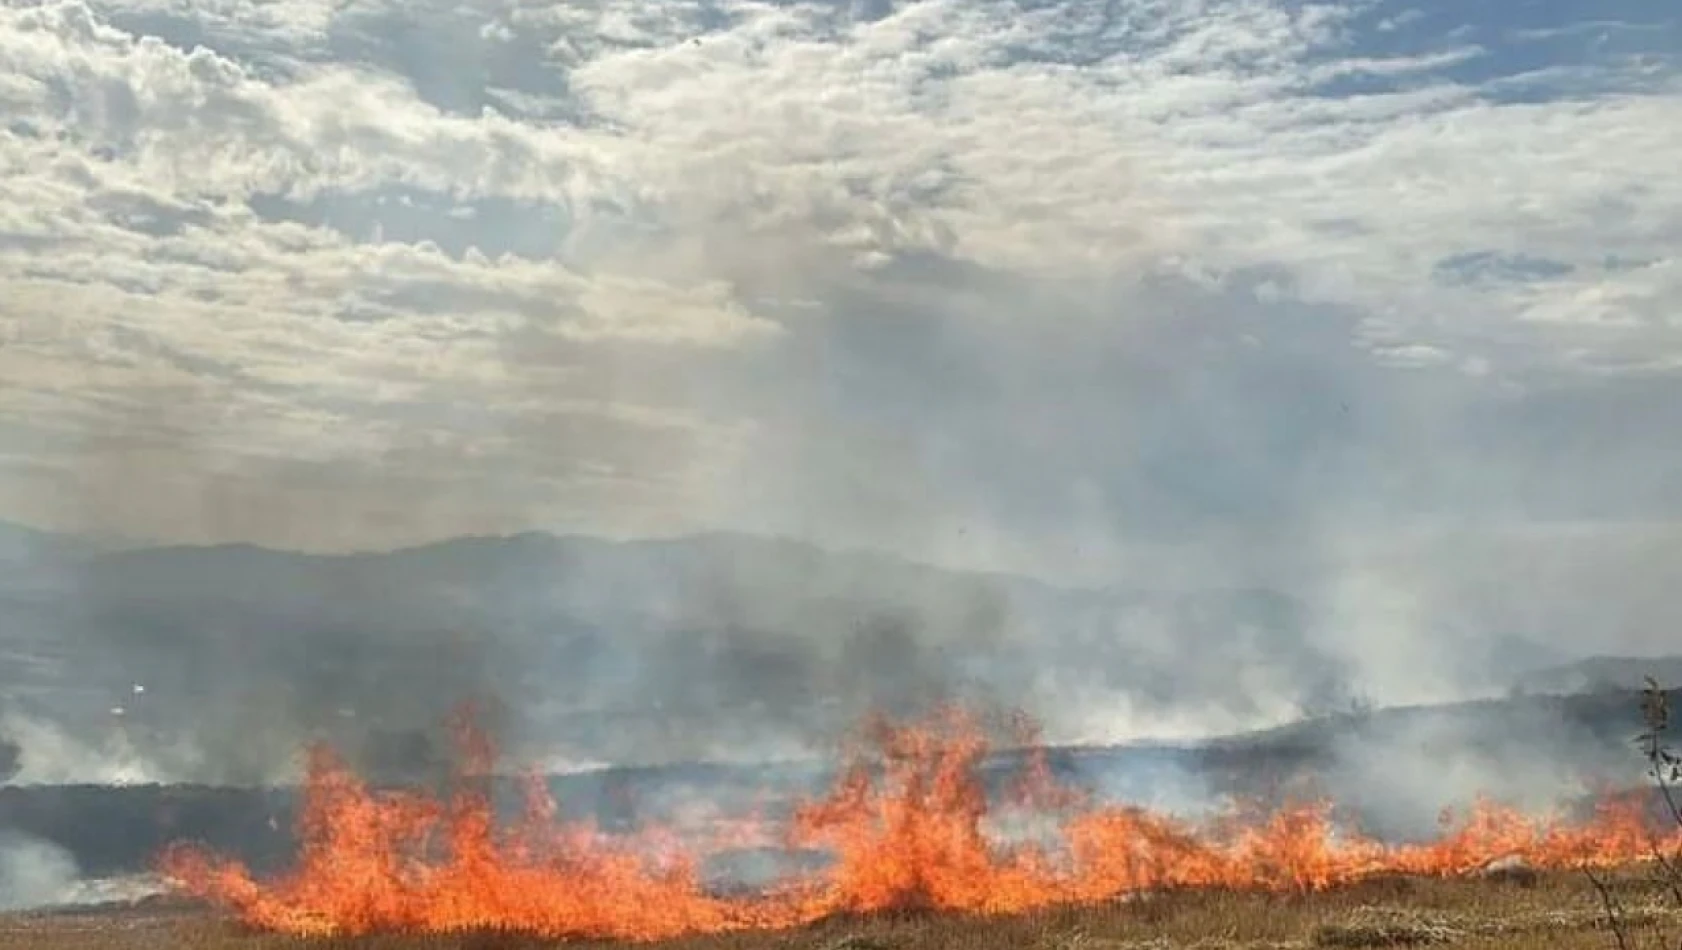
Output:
[[0, 521, 1347, 782]]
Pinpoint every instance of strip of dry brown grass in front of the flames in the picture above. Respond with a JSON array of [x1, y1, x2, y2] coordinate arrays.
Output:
[[0, 873, 1682, 950]]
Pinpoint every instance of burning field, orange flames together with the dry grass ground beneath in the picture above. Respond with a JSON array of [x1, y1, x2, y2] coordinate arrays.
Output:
[[0, 699, 1661, 950]]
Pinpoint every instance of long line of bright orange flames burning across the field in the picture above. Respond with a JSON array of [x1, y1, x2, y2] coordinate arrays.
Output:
[[161, 710, 1682, 940]]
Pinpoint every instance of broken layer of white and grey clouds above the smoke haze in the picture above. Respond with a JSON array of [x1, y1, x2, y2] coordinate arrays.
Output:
[[0, 0, 1682, 534]]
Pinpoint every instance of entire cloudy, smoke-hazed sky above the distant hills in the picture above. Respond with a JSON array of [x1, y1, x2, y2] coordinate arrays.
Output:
[[0, 0, 1682, 595]]
